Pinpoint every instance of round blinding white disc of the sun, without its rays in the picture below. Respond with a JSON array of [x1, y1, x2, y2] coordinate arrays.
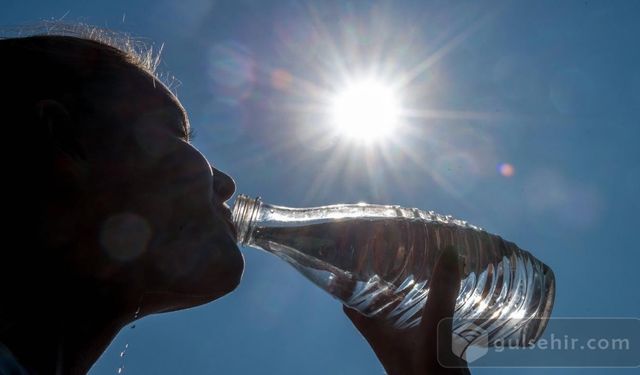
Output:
[[331, 80, 399, 142]]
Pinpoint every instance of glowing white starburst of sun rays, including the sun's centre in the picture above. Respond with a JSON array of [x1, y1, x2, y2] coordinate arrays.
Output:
[[208, 4, 510, 204]]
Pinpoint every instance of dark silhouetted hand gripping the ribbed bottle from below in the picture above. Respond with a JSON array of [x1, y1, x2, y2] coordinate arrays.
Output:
[[343, 248, 470, 375]]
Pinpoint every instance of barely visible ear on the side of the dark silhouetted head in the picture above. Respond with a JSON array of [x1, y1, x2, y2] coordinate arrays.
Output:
[[36, 99, 86, 161]]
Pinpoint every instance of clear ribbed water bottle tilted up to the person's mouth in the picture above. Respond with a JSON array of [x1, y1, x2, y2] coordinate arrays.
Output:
[[232, 195, 555, 346]]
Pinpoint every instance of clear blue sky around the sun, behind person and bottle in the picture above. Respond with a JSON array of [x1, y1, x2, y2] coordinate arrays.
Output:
[[0, 0, 640, 374]]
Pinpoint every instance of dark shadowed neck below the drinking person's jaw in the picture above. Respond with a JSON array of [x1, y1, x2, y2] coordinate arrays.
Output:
[[0, 288, 135, 375]]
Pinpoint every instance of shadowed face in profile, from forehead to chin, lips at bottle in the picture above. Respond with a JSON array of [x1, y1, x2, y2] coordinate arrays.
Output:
[[109, 72, 243, 309]]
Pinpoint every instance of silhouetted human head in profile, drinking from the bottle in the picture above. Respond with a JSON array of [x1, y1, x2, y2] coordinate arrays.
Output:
[[0, 30, 243, 328]]
